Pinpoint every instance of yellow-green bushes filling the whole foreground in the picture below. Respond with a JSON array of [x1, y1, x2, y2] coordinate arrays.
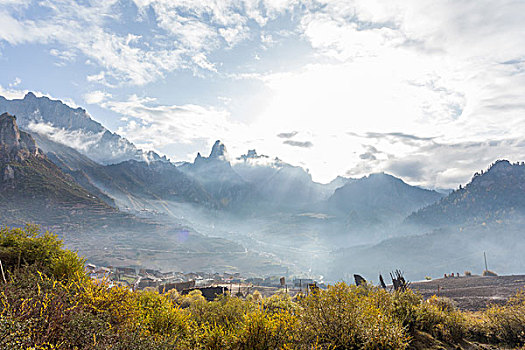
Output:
[[0, 226, 525, 349]]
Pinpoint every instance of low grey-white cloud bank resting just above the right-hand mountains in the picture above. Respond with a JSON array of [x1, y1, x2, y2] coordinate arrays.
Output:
[[346, 133, 525, 188]]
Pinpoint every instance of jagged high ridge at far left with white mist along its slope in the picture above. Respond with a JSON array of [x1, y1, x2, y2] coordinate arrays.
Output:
[[0, 92, 167, 164]]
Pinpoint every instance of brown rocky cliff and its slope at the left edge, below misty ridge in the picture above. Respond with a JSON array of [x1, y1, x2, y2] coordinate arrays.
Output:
[[0, 113, 114, 225]]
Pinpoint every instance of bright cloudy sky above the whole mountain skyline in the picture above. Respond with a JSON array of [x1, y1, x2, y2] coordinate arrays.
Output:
[[0, 0, 525, 188]]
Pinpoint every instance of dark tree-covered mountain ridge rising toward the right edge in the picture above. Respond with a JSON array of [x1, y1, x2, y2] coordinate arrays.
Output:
[[406, 160, 525, 227]]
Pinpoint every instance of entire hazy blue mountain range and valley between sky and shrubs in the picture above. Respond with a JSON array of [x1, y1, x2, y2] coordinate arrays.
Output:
[[0, 93, 525, 279]]
